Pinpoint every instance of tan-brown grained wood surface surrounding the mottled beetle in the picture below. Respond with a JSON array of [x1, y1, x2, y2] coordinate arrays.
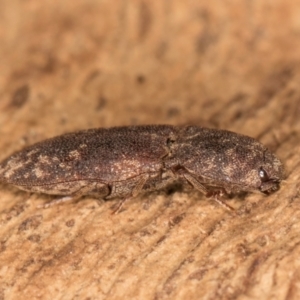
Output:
[[0, 0, 300, 299]]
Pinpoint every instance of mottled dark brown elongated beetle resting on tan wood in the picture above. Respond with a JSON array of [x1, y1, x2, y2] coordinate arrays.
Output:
[[0, 125, 283, 210]]
